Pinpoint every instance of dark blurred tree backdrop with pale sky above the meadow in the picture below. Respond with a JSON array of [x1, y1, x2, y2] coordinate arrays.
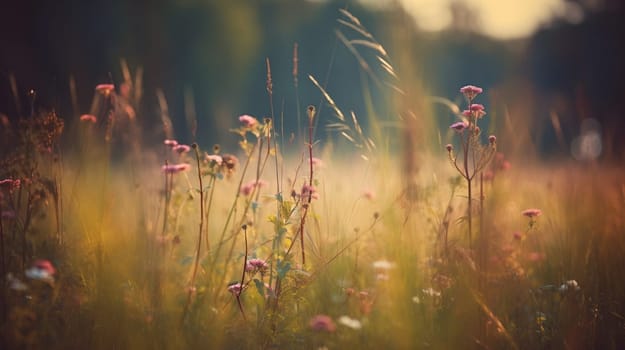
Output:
[[0, 0, 625, 161]]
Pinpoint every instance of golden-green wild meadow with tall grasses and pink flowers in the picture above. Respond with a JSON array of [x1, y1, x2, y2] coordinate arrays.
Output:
[[0, 11, 625, 349]]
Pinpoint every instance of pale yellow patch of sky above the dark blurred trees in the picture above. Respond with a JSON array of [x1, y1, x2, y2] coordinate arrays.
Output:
[[361, 0, 583, 39]]
